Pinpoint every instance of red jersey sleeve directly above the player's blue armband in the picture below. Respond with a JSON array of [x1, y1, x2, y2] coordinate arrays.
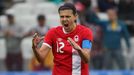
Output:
[[83, 28, 93, 42]]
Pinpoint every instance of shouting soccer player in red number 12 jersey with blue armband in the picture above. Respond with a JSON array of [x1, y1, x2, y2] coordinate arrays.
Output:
[[32, 3, 93, 75]]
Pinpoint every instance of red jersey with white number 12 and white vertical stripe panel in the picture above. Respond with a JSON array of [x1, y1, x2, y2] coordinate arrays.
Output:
[[44, 25, 93, 75]]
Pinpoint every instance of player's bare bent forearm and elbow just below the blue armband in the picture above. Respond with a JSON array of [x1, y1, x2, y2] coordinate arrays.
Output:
[[78, 49, 90, 63]]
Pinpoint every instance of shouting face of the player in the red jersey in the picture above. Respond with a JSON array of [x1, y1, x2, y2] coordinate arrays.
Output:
[[59, 9, 77, 32]]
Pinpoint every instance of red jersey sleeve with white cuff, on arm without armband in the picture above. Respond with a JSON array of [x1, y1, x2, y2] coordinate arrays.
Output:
[[44, 29, 54, 47]]
